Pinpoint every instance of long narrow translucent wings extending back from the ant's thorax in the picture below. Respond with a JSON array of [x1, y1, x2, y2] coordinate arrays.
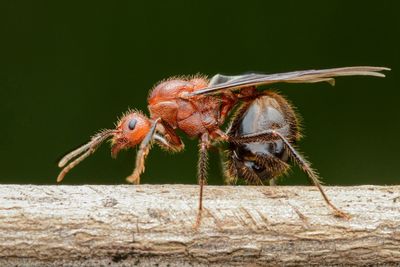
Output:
[[190, 66, 390, 95]]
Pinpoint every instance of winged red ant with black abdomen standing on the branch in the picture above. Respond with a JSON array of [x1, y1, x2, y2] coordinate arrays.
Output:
[[57, 66, 389, 222]]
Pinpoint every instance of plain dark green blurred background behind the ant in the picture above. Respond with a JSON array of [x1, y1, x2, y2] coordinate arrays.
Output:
[[0, 0, 400, 185]]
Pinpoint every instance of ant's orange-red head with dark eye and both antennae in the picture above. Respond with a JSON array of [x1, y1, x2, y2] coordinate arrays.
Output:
[[57, 111, 151, 182]]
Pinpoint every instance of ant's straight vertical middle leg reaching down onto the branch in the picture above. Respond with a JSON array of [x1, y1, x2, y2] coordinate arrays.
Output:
[[195, 133, 210, 228]]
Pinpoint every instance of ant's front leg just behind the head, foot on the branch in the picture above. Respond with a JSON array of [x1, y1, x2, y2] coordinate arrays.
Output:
[[126, 119, 160, 184]]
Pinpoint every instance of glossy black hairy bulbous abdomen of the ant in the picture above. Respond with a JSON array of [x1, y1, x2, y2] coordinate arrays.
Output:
[[228, 92, 300, 184]]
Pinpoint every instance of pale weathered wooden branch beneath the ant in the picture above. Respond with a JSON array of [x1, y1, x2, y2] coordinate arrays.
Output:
[[0, 185, 400, 266]]
